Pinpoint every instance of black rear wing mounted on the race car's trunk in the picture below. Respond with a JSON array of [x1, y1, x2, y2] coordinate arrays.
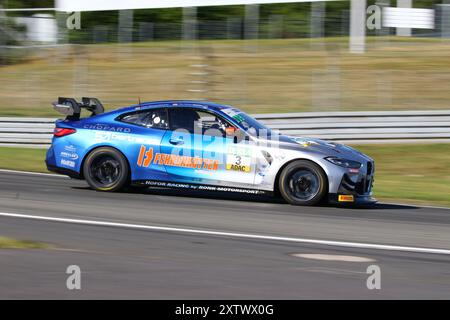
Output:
[[52, 97, 105, 121]]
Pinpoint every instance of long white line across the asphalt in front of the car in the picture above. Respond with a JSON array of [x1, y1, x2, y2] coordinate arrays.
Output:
[[0, 212, 450, 255]]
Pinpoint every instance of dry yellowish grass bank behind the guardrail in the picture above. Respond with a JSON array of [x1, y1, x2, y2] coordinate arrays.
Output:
[[0, 37, 450, 117]]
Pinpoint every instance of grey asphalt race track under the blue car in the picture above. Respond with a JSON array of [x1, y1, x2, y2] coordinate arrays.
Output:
[[0, 171, 450, 299]]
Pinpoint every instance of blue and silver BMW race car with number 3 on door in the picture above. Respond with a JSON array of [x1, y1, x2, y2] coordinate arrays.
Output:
[[46, 98, 375, 205]]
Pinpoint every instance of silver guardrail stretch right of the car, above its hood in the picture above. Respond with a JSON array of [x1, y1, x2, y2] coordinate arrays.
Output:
[[255, 110, 450, 143]]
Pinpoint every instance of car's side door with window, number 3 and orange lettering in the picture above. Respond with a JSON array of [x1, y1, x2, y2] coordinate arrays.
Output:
[[161, 107, 255, 187]]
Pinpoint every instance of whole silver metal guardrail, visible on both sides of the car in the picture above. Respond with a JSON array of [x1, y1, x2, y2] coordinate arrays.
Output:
[[0, 110, 450, 147]]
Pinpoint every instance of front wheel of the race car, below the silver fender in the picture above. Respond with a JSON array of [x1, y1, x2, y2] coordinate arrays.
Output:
[[279, 160, 328, 206]]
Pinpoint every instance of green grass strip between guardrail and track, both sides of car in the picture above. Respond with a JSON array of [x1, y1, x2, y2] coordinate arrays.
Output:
[[0, 143, 450, 207]]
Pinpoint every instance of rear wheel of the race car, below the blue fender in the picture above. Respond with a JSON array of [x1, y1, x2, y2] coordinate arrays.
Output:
[[83, 147, 130, 192]]
